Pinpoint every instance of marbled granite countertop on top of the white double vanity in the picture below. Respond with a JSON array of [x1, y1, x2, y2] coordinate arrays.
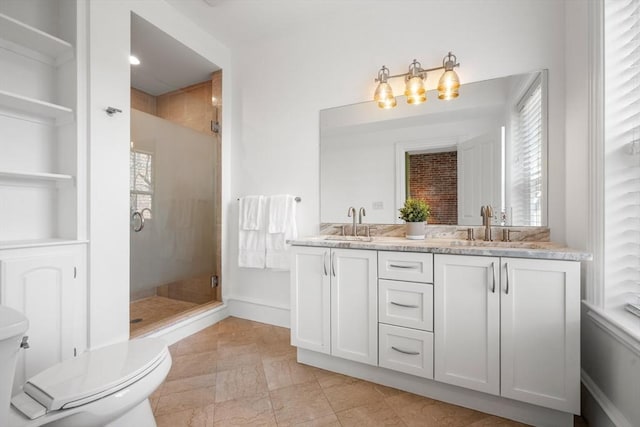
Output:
[[288, 235, 592, 261]]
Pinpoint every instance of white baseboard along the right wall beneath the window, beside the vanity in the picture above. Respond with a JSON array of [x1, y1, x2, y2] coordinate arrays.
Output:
[[581, 370, 633, 427]]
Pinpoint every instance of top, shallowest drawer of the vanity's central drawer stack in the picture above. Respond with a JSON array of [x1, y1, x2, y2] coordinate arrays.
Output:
[[378, 251, 433, 283]]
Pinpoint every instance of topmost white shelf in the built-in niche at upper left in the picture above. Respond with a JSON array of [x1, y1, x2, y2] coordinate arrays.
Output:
[[0, 13, 73, 61]]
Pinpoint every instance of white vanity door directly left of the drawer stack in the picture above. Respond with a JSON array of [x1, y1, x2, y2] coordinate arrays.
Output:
[[331, 249, 378, 365]]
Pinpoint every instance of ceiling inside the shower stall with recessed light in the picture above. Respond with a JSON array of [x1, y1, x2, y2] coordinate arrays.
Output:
[[131, 14, 220, 96]]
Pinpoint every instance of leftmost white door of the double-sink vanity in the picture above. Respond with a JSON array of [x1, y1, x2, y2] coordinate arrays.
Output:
[[291, 246, 331, 354]]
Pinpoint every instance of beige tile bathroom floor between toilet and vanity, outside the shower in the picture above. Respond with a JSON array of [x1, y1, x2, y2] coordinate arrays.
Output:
[[150, 317, 585, 427]]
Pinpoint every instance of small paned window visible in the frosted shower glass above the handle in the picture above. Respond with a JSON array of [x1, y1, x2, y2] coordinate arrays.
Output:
[[129, 150, 154, 219]]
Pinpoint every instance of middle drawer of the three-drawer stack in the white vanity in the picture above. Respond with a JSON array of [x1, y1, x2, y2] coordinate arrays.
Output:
[[378, 279, 433, 331]]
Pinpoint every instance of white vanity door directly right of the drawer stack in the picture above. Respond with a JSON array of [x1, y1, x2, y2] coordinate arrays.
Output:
[[433, 255, 500, 395]]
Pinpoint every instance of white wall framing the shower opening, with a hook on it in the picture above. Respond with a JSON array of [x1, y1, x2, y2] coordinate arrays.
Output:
[[88, 0, 233, 348]]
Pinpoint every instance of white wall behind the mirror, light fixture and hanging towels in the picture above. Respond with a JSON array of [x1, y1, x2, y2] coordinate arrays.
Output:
[[226, 0, 565, 320]]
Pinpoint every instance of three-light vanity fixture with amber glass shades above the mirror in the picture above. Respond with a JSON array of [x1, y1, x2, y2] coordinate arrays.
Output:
[[373, 52, 460, 109]]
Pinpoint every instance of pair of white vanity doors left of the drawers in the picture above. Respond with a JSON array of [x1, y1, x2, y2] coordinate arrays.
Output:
[[291, 247, 378, 365]]
